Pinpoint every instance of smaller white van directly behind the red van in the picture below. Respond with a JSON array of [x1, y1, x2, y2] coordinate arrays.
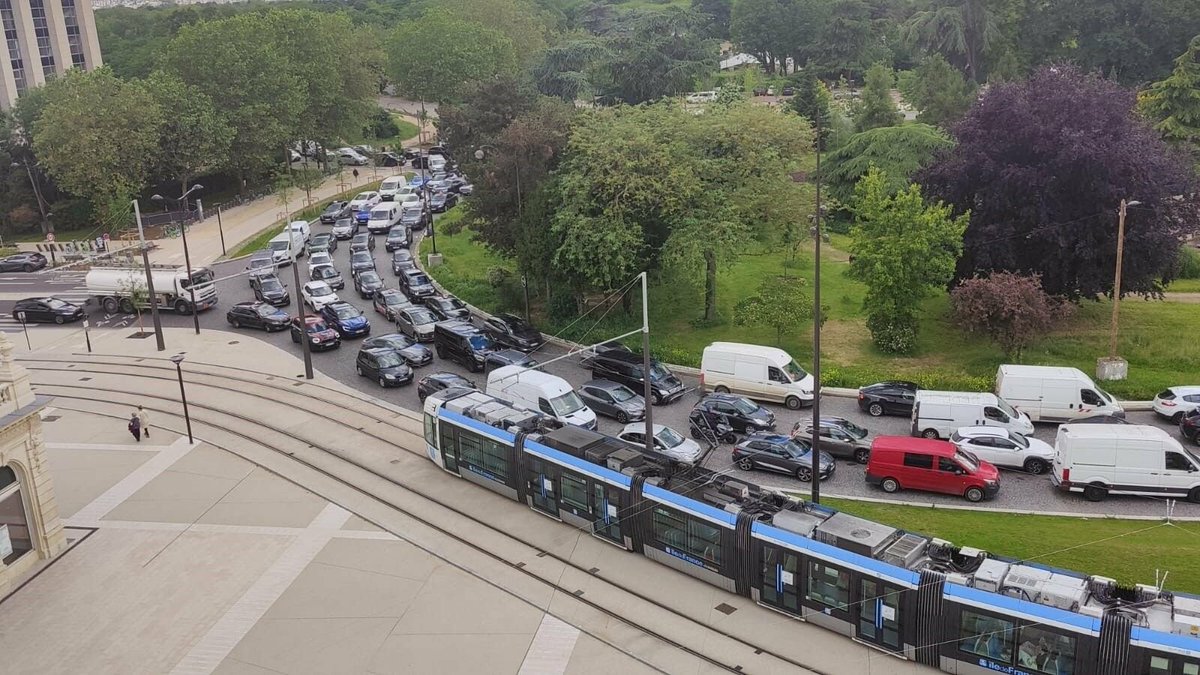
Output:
[[912, 389, 1033, 438]]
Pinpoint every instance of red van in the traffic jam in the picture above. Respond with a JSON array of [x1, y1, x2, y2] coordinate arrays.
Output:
[[866, 436, 1000, 502]]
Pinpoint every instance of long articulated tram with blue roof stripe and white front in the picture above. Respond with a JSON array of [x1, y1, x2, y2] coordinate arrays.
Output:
[[424, 389, 1200, 675]]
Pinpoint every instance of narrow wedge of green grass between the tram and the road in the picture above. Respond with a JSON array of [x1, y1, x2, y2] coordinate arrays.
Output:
[[821, 498, 1200, 593]]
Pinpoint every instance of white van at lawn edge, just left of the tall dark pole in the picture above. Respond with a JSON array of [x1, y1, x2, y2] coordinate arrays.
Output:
[[700, 342, 812, 410]]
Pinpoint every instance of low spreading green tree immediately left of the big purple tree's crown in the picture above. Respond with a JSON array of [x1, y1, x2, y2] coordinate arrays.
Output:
[[821, 124, 954, 204]]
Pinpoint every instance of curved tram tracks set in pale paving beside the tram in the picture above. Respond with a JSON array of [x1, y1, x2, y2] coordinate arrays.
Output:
[[23, 357, 835, 673]]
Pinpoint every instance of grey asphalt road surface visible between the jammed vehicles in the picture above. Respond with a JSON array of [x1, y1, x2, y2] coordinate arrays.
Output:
[[0, 212, 1200, 516]]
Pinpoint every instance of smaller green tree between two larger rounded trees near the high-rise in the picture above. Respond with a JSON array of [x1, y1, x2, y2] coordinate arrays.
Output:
[[142, 71, 235, 195]]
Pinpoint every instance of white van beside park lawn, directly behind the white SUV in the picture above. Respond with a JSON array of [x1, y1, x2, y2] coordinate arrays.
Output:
[[996, 364, 1124, 422]]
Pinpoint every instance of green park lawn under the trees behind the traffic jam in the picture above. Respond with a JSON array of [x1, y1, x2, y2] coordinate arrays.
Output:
[[422, 221, 1200, 400]]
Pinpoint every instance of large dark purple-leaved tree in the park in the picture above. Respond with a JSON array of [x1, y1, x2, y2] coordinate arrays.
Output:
[[917, 66, 1198, 299]]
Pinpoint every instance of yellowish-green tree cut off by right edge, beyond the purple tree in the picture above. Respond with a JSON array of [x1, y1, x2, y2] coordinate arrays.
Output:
[[1139, 35, 1200, 162]]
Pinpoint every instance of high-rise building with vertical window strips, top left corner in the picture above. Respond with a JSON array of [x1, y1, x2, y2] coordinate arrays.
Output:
[[0, 0, 101, 108]]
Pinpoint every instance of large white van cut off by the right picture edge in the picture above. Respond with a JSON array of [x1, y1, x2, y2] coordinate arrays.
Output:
[[1050, 424, 1200, 502]]
